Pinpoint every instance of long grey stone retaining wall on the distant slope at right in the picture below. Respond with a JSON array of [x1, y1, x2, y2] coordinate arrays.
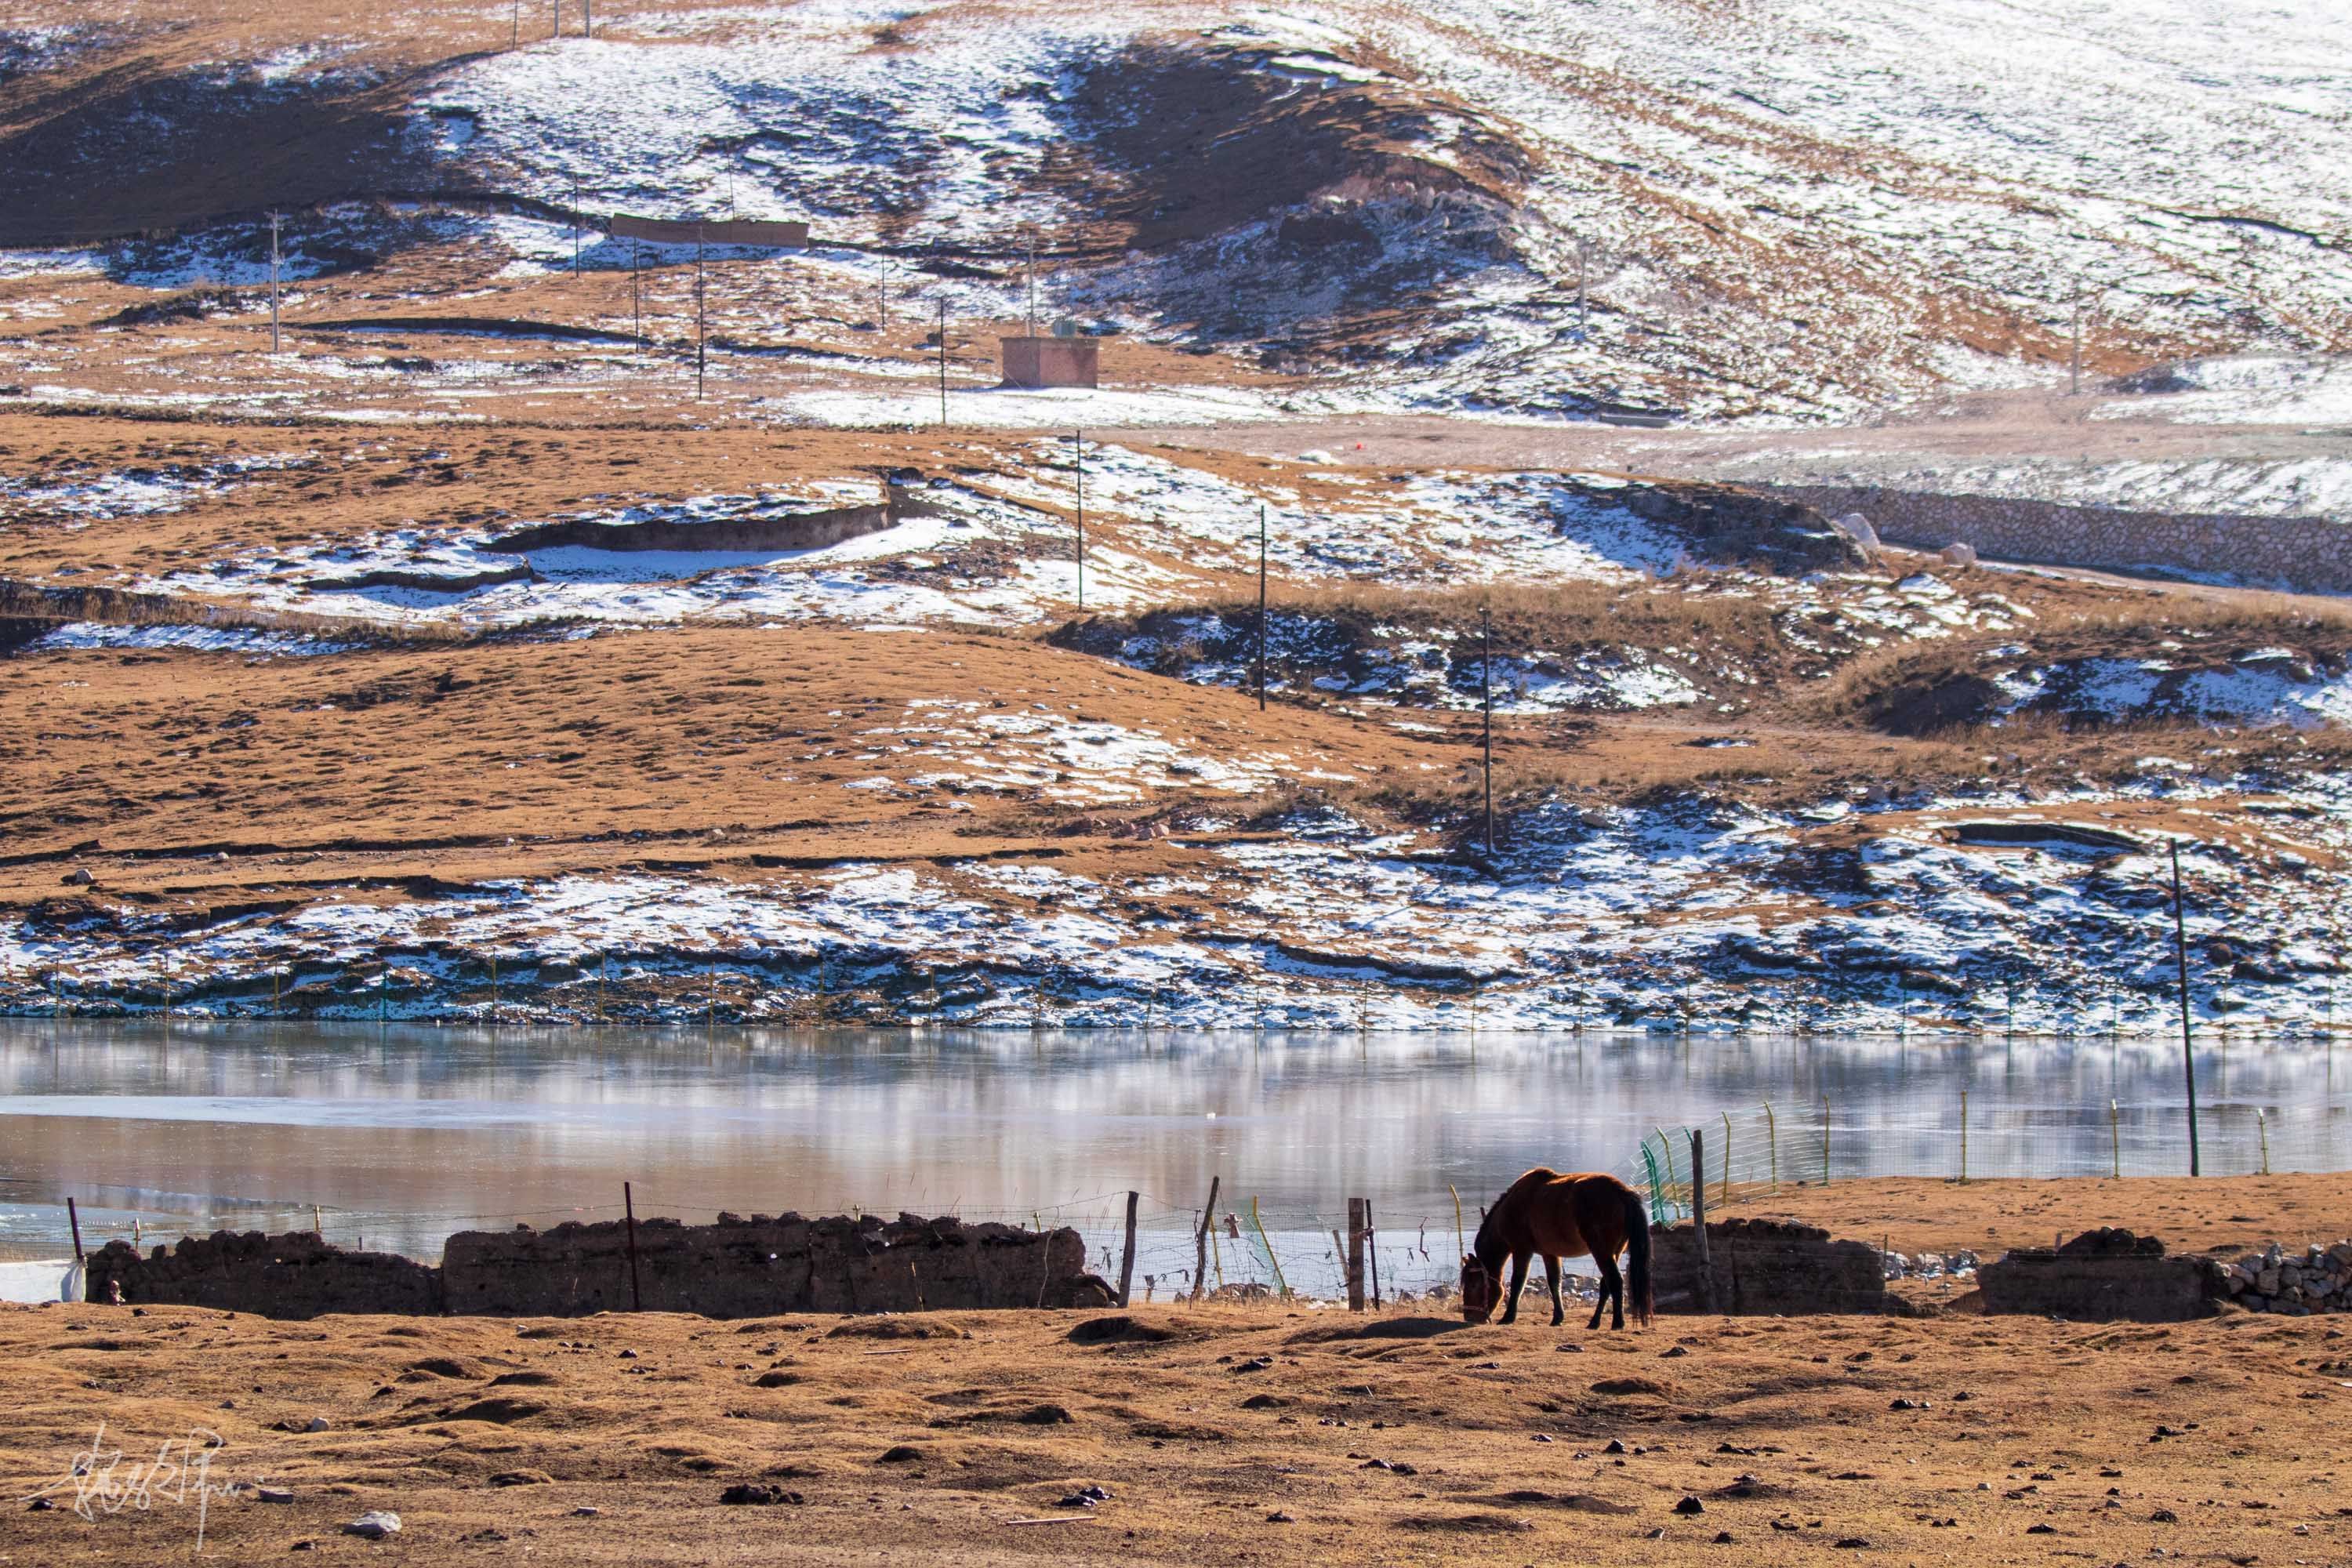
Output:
[[1752, 485, 2352, 593]]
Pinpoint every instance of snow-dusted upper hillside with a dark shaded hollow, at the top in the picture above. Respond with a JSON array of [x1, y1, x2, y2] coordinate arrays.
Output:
[[400, 0, 2352, 416]]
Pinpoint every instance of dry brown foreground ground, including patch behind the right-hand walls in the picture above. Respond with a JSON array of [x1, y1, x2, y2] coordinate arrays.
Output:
[[0, 1178, 2352, 1563]]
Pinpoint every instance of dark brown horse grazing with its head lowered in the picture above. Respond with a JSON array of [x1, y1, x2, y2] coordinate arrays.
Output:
[[1463, 1166, 1651, 1328]]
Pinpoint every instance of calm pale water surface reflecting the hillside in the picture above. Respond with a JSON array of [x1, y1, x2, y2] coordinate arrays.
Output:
[[0, 1020, 2352, 1255]]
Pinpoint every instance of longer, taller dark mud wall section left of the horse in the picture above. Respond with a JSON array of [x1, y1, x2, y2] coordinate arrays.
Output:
[[442, 1213, 1110, 1316]]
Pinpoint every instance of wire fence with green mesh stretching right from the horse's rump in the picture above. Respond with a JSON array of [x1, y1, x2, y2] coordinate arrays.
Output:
[[1621, 1093, 2352, 1225]]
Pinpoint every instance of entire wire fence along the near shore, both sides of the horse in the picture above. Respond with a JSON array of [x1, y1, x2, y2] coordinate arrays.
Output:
[[13, 1093, 2352, 1302]]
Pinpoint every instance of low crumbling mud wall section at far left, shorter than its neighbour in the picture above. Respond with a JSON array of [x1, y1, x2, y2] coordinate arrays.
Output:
[[85, 1229, 442, 1319]]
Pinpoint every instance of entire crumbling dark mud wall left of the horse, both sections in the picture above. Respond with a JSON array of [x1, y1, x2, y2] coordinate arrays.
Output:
[[87, 1213, 1110, 1319]]
